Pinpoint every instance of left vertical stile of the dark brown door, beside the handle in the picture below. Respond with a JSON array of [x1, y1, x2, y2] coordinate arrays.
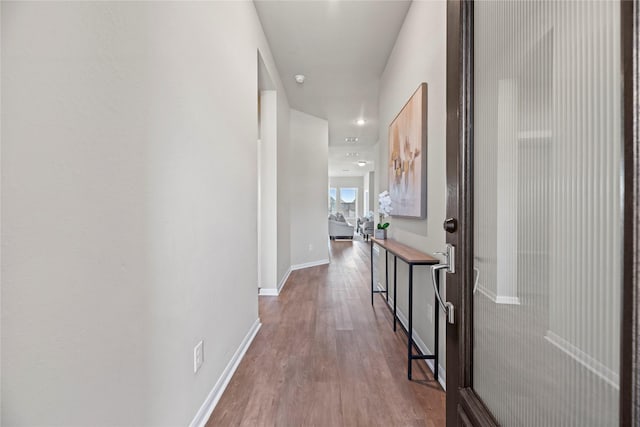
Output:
[[446, 0, 498, 426]]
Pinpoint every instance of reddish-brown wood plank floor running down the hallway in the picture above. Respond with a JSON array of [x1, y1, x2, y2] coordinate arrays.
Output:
[[207, 241, 445, 427]]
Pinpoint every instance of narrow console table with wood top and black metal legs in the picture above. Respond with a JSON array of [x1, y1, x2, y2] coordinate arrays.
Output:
[[371, 237, 440, 380]]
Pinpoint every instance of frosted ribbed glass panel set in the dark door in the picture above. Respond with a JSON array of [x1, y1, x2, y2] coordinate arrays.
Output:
[[473, 1, 622, 427]]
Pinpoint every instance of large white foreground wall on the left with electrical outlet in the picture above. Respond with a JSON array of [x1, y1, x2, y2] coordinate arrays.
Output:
[[1, 2, 288, 426]]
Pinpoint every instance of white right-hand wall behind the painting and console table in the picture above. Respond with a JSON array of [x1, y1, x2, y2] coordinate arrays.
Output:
[[374, 2, 447, 378]]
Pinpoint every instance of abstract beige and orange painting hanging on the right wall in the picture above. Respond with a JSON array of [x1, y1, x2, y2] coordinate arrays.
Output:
[[389, 83, 427, 219]]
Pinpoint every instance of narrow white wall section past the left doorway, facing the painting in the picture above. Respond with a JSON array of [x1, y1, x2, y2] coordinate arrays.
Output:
[[290, 109, 329, 266]]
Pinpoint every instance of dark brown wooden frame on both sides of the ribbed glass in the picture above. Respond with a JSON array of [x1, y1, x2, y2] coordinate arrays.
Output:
[[446, 0, 640, 427]]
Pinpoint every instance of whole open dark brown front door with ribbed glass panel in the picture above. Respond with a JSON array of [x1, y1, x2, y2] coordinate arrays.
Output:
[[443, 0, 639, 426]]
